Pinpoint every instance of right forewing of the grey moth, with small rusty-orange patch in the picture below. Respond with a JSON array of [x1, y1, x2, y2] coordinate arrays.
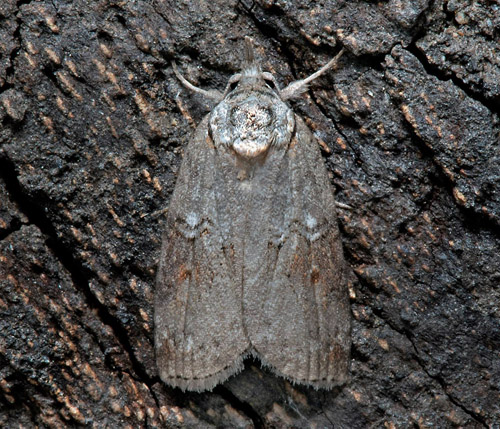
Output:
[[244, 117, 351, 388]]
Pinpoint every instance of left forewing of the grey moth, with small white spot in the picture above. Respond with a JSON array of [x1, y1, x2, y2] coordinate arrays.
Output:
[[155, 118, 249, 390]]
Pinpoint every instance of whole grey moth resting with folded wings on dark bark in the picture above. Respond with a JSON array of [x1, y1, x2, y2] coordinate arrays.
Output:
[[154, 38, 351, 391]]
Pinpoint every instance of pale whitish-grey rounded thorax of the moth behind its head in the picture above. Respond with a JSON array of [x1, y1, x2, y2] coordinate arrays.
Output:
[[209, 89, 295, 159]]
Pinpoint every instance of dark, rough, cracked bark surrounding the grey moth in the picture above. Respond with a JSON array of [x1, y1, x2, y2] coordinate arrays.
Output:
[[0, 0, 500, 428]]
